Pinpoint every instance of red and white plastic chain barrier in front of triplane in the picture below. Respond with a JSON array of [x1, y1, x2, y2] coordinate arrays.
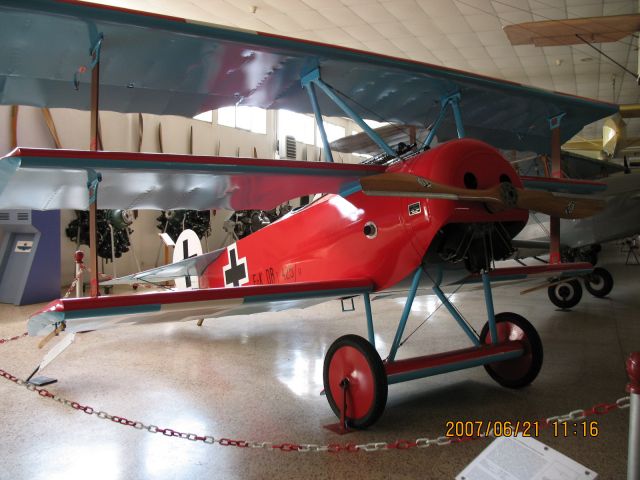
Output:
[[0, 333, 630, 453]]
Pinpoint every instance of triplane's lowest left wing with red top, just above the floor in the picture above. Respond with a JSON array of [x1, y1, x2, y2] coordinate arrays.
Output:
[[28, 279, 373, 335]]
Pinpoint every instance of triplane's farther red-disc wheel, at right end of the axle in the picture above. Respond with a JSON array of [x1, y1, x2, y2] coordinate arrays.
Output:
[[480, 312, 543, 388]]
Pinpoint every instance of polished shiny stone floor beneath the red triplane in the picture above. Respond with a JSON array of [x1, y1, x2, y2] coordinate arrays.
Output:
[[0, 248, 640, 480]]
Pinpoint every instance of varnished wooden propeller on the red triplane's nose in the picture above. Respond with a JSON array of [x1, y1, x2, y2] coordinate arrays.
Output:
[[360, 173, 604, 218]]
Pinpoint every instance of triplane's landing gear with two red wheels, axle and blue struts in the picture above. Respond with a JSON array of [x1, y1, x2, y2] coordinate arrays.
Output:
[[323, 269, 543, 432]]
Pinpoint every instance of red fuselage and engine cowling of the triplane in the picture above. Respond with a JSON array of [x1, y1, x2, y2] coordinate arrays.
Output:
[[200, 139, 528, 290]]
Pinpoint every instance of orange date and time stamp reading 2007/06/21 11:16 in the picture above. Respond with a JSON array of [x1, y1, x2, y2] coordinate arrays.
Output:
[[445, 420, 600, 438]]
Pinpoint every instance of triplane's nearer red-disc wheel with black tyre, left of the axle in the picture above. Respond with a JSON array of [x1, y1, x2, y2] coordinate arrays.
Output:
[[323, 335, 388, 428]]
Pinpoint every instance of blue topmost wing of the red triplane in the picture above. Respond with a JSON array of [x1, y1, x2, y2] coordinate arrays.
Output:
[[0, 0, 617, 153]]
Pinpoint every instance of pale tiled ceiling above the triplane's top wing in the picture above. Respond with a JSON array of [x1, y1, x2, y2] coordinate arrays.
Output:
[[86, 0, 640, 142]]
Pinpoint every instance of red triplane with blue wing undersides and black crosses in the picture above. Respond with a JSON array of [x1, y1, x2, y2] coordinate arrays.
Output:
[[0, 1, 615, 428]]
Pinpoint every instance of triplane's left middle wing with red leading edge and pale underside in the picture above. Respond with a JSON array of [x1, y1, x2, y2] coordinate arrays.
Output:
[[0, 148, 385, 210]]
